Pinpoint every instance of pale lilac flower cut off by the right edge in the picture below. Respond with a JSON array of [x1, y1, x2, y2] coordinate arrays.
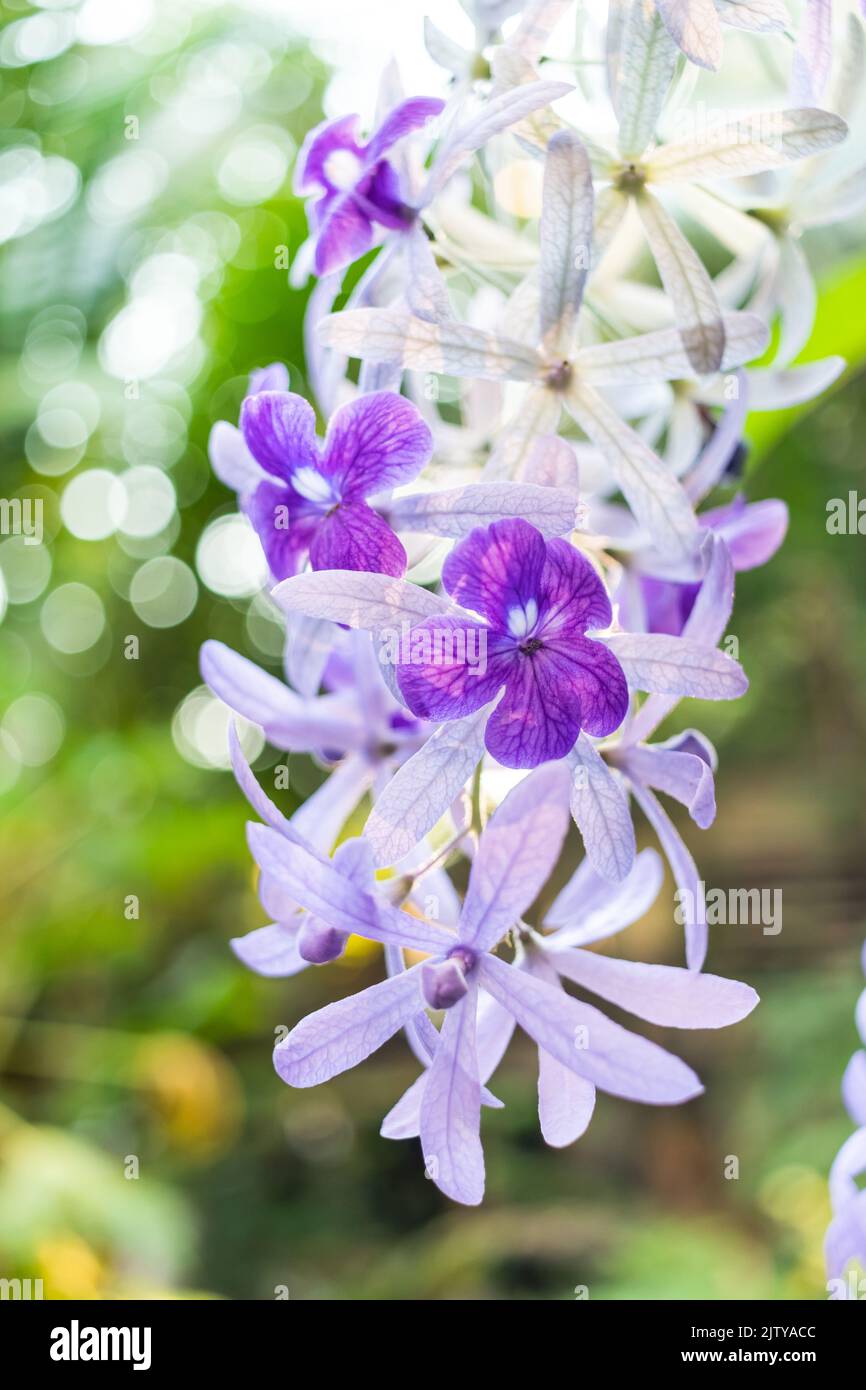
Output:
[[824, 945, 866, 1300]]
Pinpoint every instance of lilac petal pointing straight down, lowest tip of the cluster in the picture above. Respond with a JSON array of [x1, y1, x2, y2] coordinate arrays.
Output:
[[421, 981, 484, 1207]]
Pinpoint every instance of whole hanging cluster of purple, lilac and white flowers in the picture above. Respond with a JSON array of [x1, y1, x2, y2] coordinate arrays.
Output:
[[202, 0, 866, 1206]]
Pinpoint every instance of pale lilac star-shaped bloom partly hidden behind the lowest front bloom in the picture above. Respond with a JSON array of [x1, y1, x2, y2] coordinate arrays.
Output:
[[381, 839, 758, 1148]]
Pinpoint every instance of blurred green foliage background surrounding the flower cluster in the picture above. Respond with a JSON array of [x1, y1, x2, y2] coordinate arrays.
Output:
[[0, 3, 866, 1300]]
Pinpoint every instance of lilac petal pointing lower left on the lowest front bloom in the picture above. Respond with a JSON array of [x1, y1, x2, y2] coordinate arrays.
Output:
[[274, 965, 421, 1087]]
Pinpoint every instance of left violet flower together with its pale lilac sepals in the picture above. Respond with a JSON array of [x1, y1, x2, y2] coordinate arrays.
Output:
[[210, 378, 577, 580]]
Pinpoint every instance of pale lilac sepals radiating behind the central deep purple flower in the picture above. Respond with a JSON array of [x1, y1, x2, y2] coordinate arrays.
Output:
[[274, 539, 748, 880]]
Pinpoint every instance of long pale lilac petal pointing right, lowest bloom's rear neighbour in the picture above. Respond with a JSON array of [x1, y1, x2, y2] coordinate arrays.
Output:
[[546, 938, 758, 1029]]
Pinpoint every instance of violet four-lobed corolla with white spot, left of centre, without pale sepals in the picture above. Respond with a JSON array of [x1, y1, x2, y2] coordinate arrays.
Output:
[[240, 391, 432, 580]]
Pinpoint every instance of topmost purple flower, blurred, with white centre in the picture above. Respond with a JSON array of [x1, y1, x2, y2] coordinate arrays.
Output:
[[295, 97, 445, 275]]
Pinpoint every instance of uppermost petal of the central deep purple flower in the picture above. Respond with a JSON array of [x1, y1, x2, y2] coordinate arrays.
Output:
[[442, 518, 548, 632]]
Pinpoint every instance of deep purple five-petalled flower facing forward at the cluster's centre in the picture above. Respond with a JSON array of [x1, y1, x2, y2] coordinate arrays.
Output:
[[398, 520, 628, 767]]
